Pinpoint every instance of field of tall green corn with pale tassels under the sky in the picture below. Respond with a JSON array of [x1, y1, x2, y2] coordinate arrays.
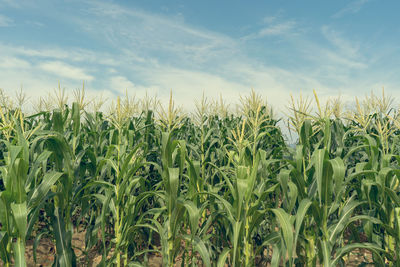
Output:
[[0, 89, 400, 267]]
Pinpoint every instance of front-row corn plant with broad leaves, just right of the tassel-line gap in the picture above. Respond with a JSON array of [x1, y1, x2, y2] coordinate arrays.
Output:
[[282, 119, 383, 266]]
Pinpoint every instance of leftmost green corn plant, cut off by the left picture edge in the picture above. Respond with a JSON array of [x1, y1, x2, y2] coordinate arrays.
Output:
[[0, 110, 62, 266]]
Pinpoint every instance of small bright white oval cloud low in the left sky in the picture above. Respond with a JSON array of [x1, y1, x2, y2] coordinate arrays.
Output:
[[38, 61, 94, 81]]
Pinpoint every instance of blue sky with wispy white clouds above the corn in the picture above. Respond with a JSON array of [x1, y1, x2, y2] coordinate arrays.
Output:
[[0, 0, 400, 112]]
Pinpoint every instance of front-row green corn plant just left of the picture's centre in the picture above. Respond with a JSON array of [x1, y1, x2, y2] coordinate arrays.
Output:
[[145, 132, 211, 266]]
